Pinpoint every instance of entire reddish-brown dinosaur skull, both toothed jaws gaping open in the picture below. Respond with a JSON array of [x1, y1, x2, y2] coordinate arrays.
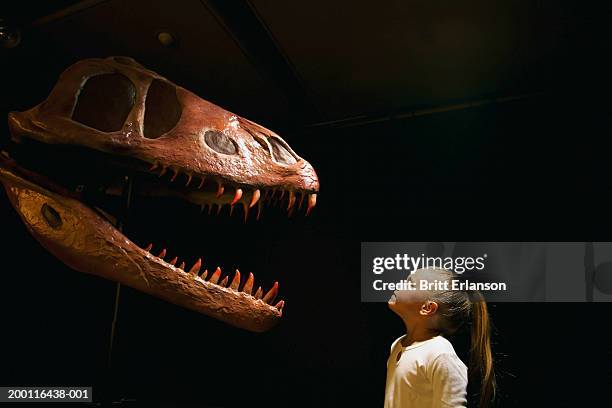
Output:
[[0, 57, 319, 331]]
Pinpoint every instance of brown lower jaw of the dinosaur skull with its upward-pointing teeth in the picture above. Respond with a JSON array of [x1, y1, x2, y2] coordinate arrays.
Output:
[[0, 155, 284, 332]]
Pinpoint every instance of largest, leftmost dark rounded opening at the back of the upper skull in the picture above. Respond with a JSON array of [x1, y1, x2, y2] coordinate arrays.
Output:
[[72, 74, 136, 132]]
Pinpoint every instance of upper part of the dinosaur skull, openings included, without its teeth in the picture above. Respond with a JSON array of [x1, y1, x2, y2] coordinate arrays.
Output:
[[9, 57, 319, 193]]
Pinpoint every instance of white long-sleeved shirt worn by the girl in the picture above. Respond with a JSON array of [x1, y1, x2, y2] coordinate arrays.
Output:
[[385, 335, 468, 408]]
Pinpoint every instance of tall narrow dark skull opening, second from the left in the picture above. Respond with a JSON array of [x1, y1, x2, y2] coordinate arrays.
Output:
[[143, 78, 183, 139]]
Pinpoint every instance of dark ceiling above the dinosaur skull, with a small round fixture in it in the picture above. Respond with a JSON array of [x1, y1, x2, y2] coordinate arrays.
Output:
[[0, 0, 605, 128]]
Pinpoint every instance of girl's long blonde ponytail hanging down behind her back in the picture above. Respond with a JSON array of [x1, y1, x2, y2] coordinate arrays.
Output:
[[469, 291, 495, 408]]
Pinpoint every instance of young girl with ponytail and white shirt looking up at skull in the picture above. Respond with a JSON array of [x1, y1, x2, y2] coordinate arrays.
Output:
[[385, 269, 495, 408]]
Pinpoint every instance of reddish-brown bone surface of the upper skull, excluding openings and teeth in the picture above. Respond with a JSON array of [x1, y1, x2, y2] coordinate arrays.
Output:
[[9, 57, 319, 193]]
